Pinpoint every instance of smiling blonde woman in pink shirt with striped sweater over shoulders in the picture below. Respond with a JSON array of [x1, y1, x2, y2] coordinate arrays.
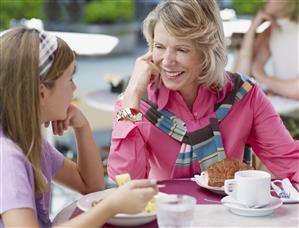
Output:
[[108, 0, 299, 181]]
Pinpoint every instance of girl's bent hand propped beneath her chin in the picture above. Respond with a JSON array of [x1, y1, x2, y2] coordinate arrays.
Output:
[[45, 104, 88, 136]]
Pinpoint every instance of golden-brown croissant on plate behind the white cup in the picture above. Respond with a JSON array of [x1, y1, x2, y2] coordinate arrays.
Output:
[[205, 159, 254, 187]]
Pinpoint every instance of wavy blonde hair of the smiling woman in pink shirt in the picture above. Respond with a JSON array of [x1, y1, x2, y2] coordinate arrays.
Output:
[[143, 0, 227, 90]]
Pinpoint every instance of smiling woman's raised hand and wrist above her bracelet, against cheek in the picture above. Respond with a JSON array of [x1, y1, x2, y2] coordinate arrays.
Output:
[[122, 51, 160, 109]]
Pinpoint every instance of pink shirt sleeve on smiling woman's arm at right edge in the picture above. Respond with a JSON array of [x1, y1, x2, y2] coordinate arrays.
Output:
[[249, 86, 299, 182]]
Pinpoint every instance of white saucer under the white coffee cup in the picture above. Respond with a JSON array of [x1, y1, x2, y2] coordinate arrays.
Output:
[[221, 196, 282, 216]]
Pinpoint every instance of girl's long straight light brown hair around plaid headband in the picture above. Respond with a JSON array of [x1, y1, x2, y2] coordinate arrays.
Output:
[[0, 28, 75, 192]]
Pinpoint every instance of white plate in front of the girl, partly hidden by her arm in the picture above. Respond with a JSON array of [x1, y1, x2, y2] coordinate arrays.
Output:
[[77, 189, 156, 226]]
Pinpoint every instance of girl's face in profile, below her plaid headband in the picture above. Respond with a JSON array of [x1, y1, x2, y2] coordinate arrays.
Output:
[[41, 61, 76, 122]]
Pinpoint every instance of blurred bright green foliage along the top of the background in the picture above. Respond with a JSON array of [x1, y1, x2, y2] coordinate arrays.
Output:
[[0, 0, 268, 29]]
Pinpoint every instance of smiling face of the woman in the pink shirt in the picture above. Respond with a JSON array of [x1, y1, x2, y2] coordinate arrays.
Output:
[[153, 22, 203, 96]]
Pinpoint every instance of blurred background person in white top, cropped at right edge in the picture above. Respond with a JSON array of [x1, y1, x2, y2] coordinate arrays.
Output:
[[235, 0, 299, 100]]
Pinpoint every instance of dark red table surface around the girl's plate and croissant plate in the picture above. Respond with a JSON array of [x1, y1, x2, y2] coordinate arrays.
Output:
[[70, 179, 223, 228]]
